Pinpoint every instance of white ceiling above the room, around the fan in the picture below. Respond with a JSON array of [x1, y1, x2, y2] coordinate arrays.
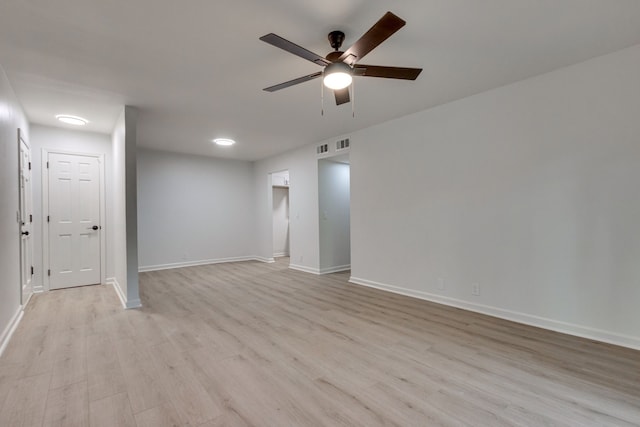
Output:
[[0, 0, 640, 160]]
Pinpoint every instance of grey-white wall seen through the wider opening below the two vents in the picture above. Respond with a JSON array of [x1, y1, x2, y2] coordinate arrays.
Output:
[[318, 160, 351, 273]]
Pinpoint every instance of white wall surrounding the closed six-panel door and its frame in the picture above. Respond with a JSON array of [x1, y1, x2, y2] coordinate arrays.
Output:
[[31, 125, 114, 289]]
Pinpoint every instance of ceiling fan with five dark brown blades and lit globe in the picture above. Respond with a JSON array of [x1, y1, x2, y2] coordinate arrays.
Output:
[[260, 12, 422, 105]]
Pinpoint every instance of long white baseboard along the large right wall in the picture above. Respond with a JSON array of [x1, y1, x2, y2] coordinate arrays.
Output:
[[349, 276, 640, 350]]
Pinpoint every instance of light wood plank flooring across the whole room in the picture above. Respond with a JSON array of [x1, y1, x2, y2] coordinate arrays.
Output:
[[0, 261, 640, 427]]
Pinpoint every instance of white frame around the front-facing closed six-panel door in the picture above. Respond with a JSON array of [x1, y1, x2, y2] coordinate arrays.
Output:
[[42, 148, 107, 291]]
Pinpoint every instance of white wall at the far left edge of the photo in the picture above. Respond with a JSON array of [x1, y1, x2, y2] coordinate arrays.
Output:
[[0, 67, 30, 353]]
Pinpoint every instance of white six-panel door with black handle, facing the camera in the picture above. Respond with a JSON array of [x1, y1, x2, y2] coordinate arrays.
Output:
[[48, 153, 102, 289]]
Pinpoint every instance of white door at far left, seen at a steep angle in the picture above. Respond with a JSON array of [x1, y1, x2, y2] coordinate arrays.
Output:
[[18, 131, 33, 305]]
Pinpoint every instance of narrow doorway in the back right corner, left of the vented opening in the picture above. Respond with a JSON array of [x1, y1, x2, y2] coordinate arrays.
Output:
[[271, 170, 290, 258]]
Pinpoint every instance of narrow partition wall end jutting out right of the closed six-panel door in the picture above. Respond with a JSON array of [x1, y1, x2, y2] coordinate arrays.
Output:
[[107, 106, 140, 308]]
